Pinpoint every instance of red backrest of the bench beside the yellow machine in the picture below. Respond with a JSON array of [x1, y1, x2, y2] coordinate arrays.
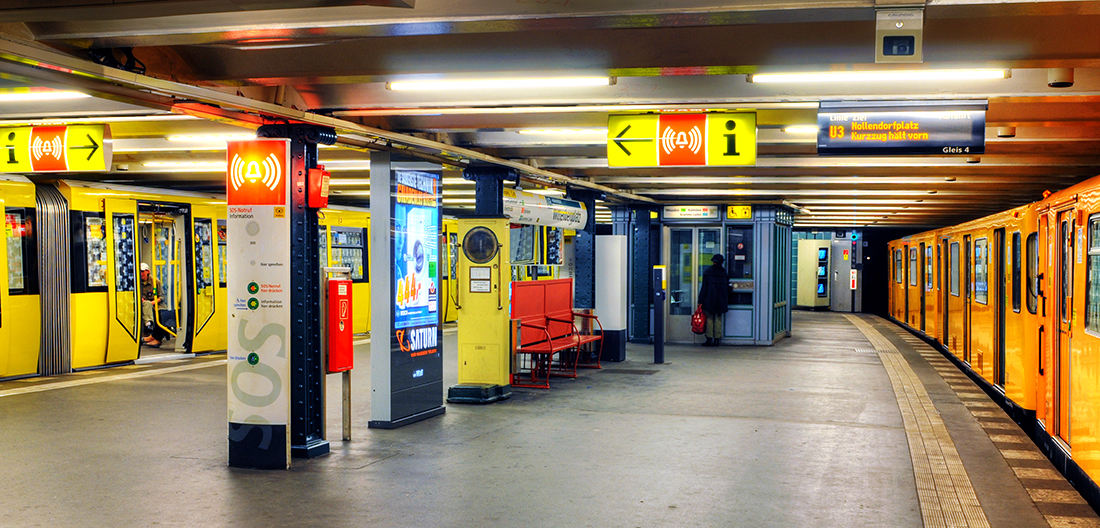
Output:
[[512, 278, 573, 347]]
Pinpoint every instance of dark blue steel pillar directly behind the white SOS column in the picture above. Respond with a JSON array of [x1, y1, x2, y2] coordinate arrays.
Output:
[[256, 124, 337, 458]]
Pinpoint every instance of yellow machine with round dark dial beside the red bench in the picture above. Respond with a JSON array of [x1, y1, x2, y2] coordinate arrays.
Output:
[[447, 217, 512, 404]]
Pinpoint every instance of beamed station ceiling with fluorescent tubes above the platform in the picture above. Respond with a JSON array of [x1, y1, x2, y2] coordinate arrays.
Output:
[[0, 0, 1100, 227]]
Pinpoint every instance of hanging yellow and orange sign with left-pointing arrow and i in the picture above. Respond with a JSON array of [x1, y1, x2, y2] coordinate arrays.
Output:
[[607, 112, 756, 167]]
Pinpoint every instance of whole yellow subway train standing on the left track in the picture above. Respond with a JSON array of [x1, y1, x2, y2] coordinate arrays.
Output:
[[0, 176, 458, 381]]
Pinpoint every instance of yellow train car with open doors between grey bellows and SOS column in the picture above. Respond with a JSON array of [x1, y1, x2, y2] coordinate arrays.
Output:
[[56, 182, 227, 370]]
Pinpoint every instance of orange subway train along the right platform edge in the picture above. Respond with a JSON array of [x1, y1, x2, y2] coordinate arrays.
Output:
[[888, 176, 1100, 507]]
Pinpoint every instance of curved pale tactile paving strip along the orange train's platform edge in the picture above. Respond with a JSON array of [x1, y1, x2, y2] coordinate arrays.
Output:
[[844, 315, 989, 528]]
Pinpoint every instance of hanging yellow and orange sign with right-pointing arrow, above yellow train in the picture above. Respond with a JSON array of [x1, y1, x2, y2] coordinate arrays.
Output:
[[0, 124, 111, 173]]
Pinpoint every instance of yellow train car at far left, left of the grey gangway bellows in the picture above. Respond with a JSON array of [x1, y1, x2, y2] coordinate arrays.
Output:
[[0, 176, 42, 380]]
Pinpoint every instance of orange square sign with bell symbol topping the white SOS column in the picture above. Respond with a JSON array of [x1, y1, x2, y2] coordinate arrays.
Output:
[[226, 139, 290, 206]]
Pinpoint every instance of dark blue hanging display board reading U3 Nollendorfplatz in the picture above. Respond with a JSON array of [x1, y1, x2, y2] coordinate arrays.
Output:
[[817, 101, 988, 156]]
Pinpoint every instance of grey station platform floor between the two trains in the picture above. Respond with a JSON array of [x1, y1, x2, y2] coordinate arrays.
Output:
[[0, 312, 1100, 527]]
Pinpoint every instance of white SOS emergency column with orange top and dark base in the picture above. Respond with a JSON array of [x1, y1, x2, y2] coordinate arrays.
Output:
[[226, 139, 290, 469]]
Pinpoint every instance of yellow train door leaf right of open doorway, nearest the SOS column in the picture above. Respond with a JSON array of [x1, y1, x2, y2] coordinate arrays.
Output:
[[189, 206, 217, 352]]
